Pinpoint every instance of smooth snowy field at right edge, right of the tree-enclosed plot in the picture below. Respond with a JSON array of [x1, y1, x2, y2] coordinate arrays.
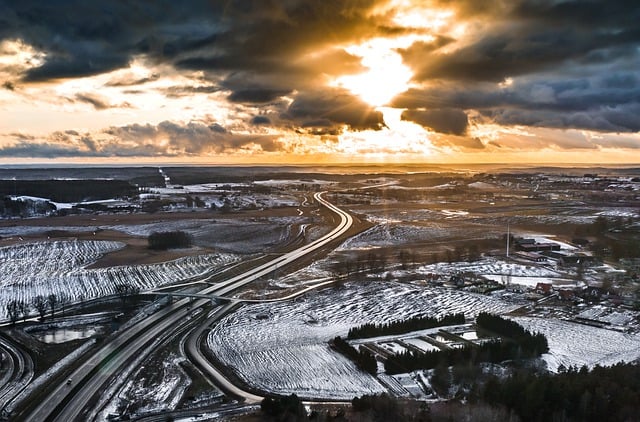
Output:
[[514, 317, 640, 372]]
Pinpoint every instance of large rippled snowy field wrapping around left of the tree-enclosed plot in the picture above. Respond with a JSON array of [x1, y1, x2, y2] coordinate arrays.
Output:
[[208, 281, 514, 399]]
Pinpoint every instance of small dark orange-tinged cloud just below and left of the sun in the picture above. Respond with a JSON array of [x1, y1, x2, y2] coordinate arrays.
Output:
[[283, 89, 384, 130]]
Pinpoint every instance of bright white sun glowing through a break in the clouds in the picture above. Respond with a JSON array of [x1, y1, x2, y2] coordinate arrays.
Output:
[[332, 37, 413, 107]]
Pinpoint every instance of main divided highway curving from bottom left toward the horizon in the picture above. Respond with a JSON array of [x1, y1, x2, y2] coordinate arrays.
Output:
[[27, 192, 353, 422]]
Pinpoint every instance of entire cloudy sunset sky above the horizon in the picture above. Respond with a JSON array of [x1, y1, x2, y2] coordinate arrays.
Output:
[[0, 0, 640, 164]]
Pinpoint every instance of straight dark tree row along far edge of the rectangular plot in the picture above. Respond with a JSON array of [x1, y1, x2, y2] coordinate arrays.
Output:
[[347, 313, 465, 339]]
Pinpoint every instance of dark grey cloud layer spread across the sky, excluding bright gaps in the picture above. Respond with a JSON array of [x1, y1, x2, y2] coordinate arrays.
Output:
[[0, 0, 640, 155]]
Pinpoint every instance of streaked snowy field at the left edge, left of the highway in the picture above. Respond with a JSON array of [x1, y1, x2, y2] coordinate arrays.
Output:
[[0, 240, 236, 320]]
